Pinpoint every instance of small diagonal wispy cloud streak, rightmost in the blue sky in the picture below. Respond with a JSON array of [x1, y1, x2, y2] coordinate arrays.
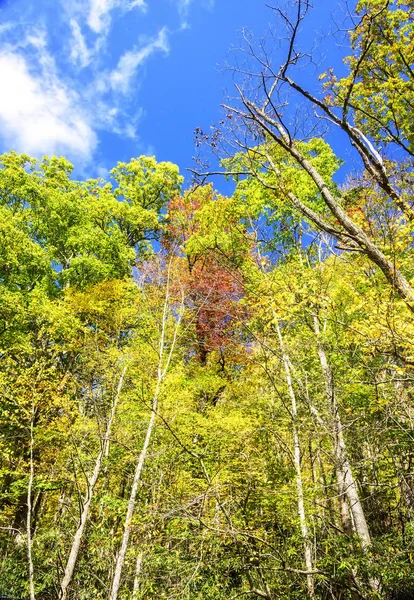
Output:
[[109, 27, 169, 93]]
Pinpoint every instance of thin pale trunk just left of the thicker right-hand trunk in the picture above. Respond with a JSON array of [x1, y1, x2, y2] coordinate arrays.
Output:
[[276, 323, 315, 598]]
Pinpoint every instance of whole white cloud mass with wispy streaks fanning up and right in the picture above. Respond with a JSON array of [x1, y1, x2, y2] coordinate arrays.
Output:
[[0, 19, 163, 161]]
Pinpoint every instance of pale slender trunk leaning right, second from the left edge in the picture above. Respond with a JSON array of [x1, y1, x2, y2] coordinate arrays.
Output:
[[60, 367, 127, 600]]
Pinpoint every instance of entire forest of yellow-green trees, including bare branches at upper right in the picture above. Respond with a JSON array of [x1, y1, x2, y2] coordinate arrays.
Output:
[[0, 0, 414, 600]]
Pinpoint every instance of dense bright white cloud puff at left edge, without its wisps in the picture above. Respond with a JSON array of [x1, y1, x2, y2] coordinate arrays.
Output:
[[0, 51, 96, 158]]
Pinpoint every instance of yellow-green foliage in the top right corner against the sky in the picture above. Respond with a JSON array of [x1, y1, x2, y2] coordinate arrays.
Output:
[[327, 0, 414, 153]]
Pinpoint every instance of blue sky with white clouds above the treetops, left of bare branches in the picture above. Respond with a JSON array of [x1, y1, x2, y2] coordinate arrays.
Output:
[[0, 0, 350, 185]]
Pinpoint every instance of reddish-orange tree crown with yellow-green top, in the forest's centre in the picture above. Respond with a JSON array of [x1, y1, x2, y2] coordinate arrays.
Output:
[[164, 185, 251, 369]]
